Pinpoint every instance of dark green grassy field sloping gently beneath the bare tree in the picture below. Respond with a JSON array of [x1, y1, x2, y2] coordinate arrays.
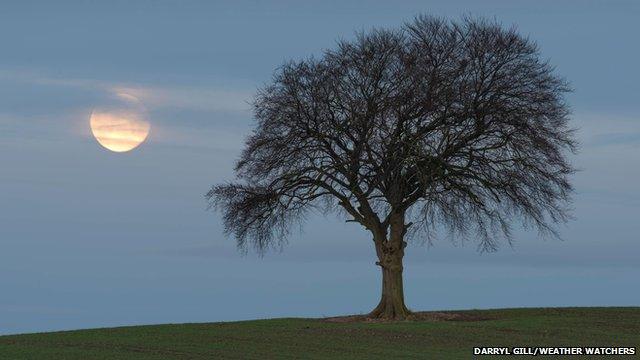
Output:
[[0, 307, 640, 360]]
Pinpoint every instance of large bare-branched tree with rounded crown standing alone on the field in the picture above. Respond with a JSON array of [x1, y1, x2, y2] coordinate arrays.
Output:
[[207, 16, 577, 319]]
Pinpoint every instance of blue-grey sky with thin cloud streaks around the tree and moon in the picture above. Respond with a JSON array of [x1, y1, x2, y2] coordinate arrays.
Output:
[[0, 0, 640, 334]]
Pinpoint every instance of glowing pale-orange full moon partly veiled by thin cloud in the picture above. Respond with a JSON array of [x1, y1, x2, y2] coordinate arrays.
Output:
[[89, 94, 151, 152]]
